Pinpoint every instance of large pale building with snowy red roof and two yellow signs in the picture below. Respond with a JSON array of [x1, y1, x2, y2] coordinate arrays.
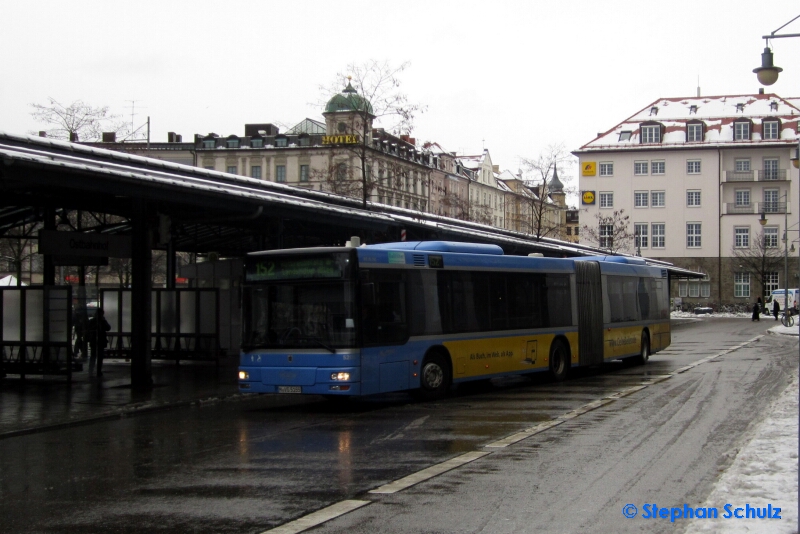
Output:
[[574, 94, 800, 307]]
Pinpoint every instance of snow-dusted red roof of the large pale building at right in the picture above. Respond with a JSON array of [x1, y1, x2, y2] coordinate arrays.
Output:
[[576, 94, 800, 153]]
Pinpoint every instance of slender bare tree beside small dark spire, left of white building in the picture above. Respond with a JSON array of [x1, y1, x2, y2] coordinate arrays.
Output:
[[518, 143, 574, 238]]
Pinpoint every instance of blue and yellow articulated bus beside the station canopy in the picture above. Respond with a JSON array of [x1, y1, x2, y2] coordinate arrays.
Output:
[[239, 238, 670, 398]]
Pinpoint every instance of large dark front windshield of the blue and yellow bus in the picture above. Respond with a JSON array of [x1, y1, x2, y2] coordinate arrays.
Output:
[[242, 280, 356, 352]]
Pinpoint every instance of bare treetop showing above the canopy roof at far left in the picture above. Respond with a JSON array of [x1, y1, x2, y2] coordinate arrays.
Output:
[[31, 98, 125, 142]]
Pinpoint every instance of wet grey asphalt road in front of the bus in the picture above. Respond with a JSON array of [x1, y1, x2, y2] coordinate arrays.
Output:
[[0, 319, 798, 533]]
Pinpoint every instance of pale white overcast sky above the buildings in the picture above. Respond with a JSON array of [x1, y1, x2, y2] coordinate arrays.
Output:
[[0, 0, 800, 191]]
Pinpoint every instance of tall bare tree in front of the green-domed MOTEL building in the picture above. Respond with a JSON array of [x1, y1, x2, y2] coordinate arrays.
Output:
[[320, 60, 425, 208]]
